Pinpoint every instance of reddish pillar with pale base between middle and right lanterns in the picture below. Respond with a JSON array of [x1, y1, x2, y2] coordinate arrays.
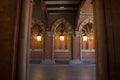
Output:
[[70, 31, 81, 64]]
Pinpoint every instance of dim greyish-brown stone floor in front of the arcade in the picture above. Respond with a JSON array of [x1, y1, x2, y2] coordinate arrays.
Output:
[[29, 64, 96, 80]]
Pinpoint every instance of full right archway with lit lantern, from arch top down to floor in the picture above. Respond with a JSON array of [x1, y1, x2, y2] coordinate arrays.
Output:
[[79, 17, 96, 64]]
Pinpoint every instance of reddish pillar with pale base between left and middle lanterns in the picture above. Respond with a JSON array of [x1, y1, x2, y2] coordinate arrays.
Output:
[[41, 31, 55, 64]]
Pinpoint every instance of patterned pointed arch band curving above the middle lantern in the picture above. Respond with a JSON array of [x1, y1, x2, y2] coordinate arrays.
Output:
[[51, 18, 72, 32]]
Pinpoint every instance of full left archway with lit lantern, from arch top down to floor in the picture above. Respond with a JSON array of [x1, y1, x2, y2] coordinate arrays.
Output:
[[30, 19, 45, 63]]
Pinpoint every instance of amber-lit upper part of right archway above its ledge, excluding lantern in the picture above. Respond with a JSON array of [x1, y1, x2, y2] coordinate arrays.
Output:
[[79, 17, 95, 50]]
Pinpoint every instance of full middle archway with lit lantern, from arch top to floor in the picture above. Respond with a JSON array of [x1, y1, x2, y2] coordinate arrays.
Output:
[[51, 18, 72, 64]]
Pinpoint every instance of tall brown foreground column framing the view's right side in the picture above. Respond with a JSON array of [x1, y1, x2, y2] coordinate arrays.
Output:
[[92, 0, 110, 80]]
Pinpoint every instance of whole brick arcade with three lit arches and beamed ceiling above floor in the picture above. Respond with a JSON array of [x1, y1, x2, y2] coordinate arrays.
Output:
[[29, 0, 95, 64]]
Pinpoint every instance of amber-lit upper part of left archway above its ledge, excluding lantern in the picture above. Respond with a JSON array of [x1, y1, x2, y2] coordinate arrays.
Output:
[[30, 19, 45, 49]]
